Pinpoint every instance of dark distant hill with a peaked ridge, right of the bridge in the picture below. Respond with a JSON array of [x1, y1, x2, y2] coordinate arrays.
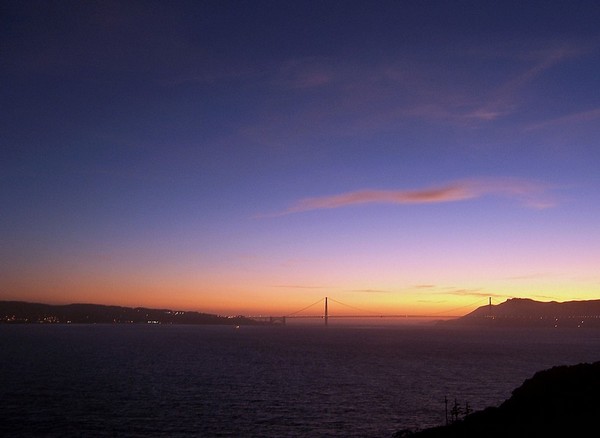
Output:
[[443, 298, 600, 328]]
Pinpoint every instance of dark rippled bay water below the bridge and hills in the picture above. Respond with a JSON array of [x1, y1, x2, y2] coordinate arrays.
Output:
[[0, 325, 600, 437]]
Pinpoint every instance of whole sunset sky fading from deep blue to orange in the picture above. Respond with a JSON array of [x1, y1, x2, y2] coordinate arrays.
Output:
[[0, 0, 600, 316]]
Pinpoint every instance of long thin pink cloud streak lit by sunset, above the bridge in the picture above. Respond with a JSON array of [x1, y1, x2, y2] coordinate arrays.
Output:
[[276, 175, 555, 216]]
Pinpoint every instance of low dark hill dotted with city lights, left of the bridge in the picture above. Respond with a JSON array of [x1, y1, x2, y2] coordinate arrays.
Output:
[[0, 301, 258, 325]]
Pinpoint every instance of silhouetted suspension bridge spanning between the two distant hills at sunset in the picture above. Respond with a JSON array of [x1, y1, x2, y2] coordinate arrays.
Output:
[[251, 297, 492, 325]]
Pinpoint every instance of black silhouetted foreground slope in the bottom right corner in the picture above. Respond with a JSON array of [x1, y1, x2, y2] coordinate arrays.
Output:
[[394, 362, 600, 438]]
